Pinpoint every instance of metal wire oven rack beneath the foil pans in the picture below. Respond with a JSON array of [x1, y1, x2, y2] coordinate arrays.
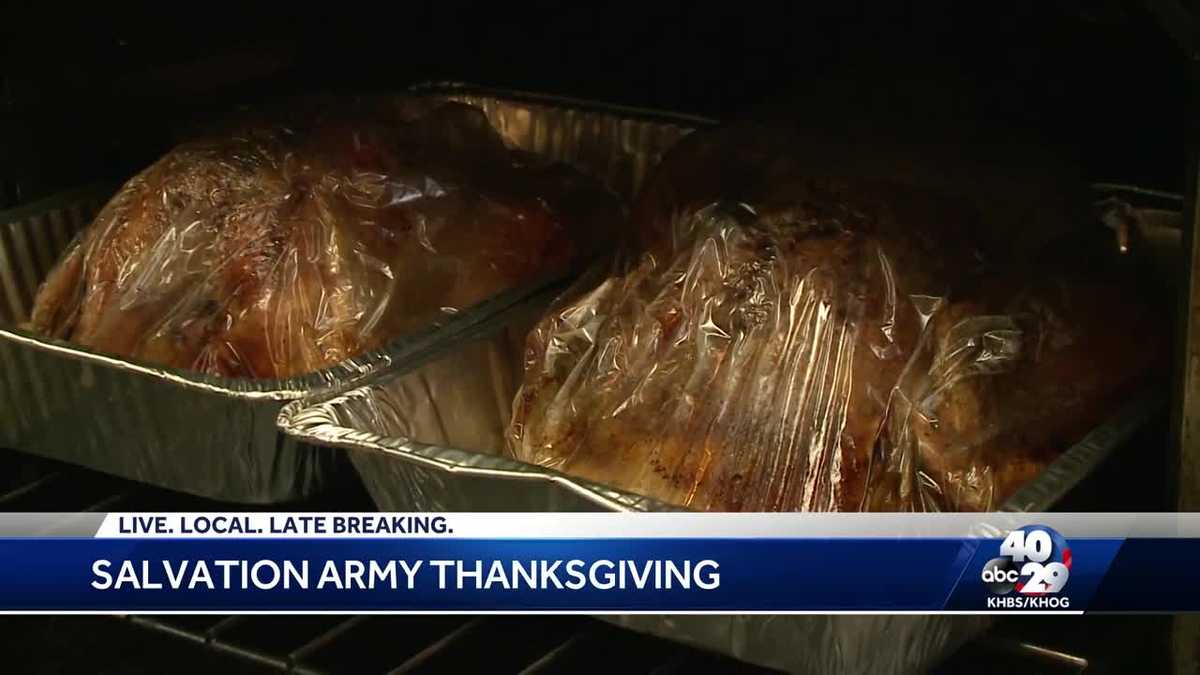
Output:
[[0, 450, 1152, 675]]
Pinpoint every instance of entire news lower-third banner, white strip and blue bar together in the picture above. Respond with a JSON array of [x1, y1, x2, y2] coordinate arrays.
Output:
[[0, 513, 1200, 614]]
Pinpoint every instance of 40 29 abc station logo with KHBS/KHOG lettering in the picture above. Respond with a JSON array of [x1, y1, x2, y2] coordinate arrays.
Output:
[[979, 525, 1070, 609]]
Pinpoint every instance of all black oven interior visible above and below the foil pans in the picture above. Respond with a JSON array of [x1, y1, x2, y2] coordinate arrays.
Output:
[[0, 0, 1190, 674]]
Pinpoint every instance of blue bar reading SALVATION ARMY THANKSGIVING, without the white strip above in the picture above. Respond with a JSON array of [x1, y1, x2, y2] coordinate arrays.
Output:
[[0, 514, 1200, 614]]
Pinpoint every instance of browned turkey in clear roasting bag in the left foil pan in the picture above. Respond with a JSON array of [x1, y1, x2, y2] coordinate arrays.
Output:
[[30, 98, 622, 378]]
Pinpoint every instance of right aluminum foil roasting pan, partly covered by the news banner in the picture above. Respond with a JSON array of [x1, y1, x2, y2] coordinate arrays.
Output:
[[280, 176, 1174, 675]]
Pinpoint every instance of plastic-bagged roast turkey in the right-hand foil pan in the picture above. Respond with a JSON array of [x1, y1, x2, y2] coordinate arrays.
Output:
[[509, 119, 1164, 510]]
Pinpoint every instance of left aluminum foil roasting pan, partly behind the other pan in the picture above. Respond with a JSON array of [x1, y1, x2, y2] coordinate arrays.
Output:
[[0, 84, 706, 503]]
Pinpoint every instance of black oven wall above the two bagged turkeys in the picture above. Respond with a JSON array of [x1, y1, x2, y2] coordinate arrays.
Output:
[[0, 0, 1183, 207]]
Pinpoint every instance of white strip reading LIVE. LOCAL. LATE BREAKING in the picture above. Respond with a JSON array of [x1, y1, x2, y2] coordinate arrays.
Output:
[[82, 513, 1200, 539]]
